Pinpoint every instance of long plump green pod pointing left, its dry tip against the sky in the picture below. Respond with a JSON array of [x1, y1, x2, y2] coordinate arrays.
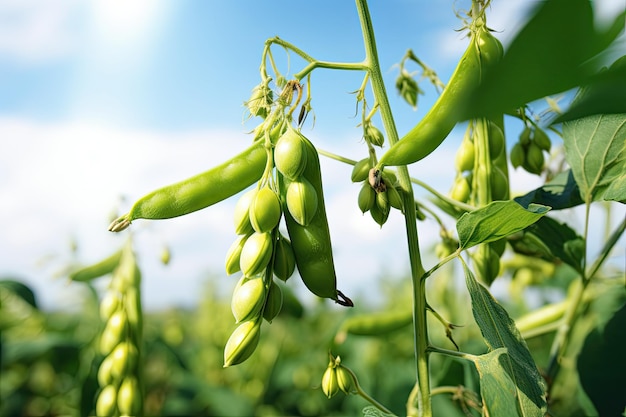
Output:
[[109, 141, 267, 232]]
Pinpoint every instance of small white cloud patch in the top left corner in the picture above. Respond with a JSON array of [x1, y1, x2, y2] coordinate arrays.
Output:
[[0, 0, 85, 63]]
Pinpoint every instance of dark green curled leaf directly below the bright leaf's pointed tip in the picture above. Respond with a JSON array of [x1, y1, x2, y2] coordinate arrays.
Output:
[[509, 216, 585, 273]]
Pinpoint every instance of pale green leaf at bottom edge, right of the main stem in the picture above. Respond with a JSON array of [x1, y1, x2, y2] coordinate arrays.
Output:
[[470, 348, 520, 417]]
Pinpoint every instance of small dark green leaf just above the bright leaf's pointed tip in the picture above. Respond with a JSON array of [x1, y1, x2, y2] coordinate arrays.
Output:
[[514, 169, 584, 210]]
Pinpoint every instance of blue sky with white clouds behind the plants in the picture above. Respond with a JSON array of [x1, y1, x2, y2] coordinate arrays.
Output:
[[0, 0, 623, 308]]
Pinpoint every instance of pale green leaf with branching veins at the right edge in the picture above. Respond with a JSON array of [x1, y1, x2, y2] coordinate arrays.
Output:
[[563, 113, 626, 203]]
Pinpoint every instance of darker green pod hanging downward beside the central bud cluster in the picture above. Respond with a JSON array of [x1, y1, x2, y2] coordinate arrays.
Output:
[[278, 136, 338, 300]]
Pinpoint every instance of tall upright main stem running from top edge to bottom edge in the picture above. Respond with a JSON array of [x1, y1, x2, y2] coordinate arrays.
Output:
[[356, 0, 432, 417]]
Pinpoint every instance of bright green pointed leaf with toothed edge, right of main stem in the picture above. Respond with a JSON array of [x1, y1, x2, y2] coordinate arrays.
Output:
[[456, 200, 550, 249]]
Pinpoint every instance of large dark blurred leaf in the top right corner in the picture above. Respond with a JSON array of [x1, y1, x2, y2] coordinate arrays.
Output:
[[458, 0, 625, 119]]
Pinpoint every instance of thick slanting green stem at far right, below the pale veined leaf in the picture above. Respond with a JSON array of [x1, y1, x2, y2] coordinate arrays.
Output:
[[547, 211, 626, 379]]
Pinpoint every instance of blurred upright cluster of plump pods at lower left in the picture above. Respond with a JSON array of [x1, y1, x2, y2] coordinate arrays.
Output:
[[96, 244, 143, 416]]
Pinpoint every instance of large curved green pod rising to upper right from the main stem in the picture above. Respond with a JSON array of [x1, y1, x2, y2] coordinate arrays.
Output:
[[379, 26, 502, 166]]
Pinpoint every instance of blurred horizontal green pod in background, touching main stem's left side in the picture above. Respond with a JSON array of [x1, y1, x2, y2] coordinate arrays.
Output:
[[340, 309, 413, 336]]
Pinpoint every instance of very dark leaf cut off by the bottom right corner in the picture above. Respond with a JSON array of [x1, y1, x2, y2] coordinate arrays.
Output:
[[577, 304, 626, 416]]
